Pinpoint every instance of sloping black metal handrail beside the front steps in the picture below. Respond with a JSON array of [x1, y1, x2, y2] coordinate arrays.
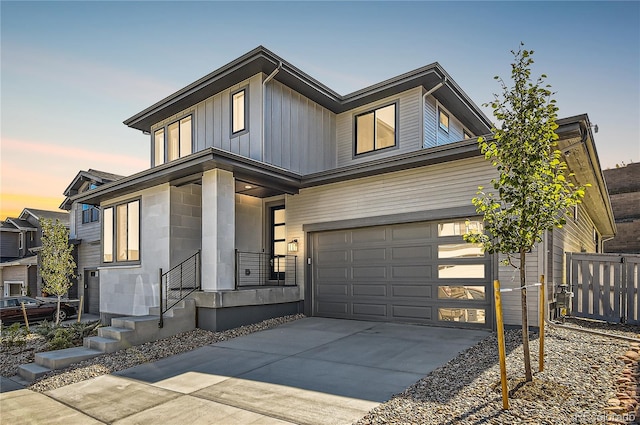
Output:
[[158, 250, 201, 327]]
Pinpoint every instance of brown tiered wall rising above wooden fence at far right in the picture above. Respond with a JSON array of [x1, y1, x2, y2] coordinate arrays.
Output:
[[604, 163, 640, 254]]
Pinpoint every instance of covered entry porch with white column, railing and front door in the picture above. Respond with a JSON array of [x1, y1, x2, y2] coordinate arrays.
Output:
[[163, 169, 302, 330]]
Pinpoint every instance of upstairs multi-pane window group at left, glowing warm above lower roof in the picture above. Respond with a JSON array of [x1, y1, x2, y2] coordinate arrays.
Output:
[[153, 115, 193, 166]]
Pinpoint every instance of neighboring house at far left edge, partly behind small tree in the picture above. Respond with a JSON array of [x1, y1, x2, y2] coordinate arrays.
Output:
[[0, 208, 69, 297]]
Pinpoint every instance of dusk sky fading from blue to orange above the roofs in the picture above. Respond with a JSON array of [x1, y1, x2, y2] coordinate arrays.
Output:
[[0, 1, 640, 219]]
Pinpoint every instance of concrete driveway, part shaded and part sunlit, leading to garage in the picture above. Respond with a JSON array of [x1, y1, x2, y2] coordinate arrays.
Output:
[[0, 317, 489, 425]]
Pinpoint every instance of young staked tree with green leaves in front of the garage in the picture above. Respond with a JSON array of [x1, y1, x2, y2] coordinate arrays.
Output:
[[464, 43, 585, 381]]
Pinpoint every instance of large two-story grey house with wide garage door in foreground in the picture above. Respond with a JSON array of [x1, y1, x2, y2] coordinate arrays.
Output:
[[70, 47, 615, 329]]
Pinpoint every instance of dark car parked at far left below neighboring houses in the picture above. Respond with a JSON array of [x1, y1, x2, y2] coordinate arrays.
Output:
[[0, 297, 77, 324]]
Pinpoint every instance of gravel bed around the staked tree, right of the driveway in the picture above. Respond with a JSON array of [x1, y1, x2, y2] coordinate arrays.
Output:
[[358, 321, 640, 425]]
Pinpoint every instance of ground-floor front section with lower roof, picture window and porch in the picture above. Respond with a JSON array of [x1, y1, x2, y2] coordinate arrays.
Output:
[[73, 150, 302, 330]]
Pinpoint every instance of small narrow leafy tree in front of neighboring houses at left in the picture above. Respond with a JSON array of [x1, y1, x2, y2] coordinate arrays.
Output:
[[40, 219, 76, 325]]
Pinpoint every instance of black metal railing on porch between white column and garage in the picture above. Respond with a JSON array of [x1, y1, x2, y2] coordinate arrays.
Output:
[[235, 250, 298, 289]]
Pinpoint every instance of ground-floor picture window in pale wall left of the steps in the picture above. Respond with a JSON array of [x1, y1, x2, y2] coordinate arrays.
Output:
[[102, 200, 140, 263]]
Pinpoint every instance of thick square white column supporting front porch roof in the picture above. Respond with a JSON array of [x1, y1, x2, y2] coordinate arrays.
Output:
[[201, 169, 235, 291]]
